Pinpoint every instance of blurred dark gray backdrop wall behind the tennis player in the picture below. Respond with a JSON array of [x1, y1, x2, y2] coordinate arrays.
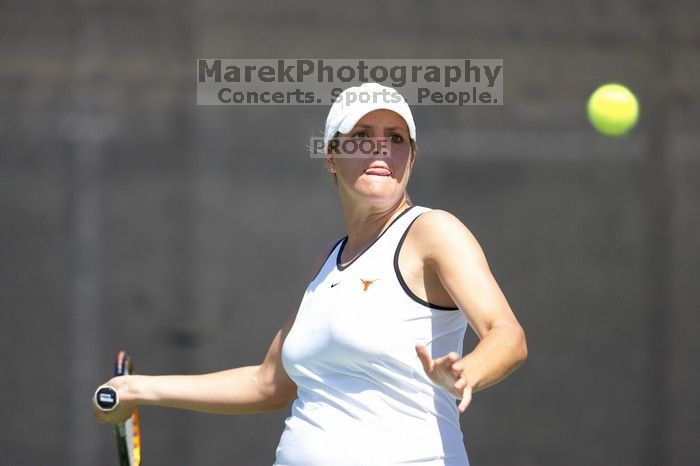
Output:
[[0, 0, 700, 466]]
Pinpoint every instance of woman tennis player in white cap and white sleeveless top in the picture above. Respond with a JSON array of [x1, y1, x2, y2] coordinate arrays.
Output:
[[95, 83, 527, 466]]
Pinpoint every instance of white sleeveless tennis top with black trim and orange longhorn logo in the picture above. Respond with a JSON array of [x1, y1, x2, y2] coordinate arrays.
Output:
[[275, 206, 469, 466]]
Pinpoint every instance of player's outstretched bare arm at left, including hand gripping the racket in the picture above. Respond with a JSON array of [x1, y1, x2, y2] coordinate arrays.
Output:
[[93, 238, 334, 423]]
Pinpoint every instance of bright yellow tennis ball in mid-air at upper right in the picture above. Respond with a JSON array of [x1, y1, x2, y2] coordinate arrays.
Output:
[[588, 83, 639, 136]]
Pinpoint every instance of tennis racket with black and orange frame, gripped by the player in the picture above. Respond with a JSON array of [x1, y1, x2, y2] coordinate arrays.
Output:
[[95, 351, 141, 466]]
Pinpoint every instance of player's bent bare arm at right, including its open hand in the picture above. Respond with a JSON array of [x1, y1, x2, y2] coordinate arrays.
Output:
[[412, 210, 527, 412]]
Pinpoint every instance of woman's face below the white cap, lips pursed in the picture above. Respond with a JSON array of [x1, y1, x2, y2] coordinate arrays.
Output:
[[326, 109, 415, 206]]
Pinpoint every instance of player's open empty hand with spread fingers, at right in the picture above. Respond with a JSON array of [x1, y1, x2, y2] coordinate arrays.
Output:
[[416, 343, 472, 413]]
